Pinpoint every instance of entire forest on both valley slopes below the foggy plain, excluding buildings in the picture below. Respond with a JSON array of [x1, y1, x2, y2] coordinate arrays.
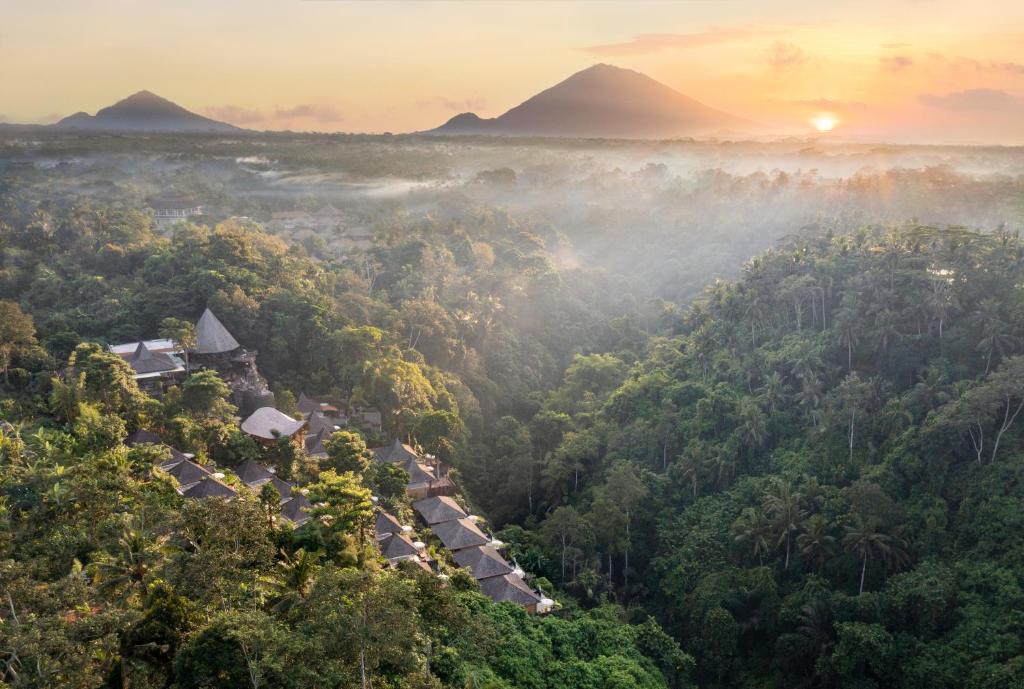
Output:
[[0, 184, 1024, 689]]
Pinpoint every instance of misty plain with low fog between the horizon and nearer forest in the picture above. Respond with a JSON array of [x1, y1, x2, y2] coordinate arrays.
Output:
[[0, 135, 1024, 300]]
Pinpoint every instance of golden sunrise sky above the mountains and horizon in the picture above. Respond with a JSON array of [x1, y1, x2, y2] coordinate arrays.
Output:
[[6, 0, 1024, 143]]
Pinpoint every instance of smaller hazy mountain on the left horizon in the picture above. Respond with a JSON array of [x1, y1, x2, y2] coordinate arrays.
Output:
[[53, 91, 241, 133]]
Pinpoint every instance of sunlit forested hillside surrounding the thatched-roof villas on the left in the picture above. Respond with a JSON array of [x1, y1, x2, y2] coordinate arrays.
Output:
[[0, 204, 691, 689]]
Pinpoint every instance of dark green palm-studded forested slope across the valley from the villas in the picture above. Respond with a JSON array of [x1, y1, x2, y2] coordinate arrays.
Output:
[[474, 227, 1024, 689]]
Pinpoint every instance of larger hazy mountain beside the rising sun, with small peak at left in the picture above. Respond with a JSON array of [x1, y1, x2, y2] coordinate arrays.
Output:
[[425, 64, 751, 138]]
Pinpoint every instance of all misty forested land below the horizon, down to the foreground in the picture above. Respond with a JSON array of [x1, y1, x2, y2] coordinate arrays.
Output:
[[0, 129, 1024, 689]]
